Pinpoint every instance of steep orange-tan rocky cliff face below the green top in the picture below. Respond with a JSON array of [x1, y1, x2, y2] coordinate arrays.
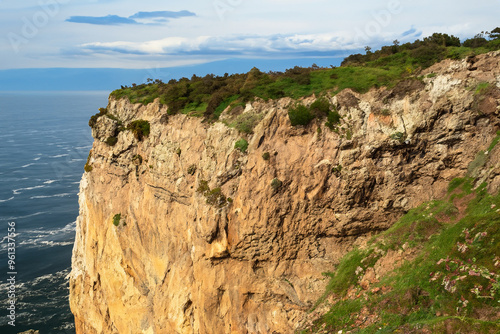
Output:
[[70, 52, 500, 334]]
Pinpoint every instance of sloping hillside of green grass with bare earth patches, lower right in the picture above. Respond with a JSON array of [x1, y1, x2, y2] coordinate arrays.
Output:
[[301, 132, 500, 333]]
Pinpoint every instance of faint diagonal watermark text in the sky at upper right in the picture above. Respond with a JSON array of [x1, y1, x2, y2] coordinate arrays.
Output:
[[354, 0, 403, 44]]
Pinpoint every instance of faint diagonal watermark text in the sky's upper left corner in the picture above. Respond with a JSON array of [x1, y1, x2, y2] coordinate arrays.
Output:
[[7, 0, 70, 53]]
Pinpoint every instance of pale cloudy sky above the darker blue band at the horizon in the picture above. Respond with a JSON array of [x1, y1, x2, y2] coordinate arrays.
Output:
[[0, 0, 500, 88]]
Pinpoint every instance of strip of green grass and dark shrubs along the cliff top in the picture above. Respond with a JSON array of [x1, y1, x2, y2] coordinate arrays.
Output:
[[111, 28, 500, 119]]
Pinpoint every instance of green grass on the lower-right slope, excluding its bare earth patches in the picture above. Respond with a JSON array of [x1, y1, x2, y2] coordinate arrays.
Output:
[[309, 182, 500, 333]]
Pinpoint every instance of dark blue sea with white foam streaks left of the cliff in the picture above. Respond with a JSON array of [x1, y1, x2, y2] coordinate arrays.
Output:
[[0, 91, 109, 334]]
